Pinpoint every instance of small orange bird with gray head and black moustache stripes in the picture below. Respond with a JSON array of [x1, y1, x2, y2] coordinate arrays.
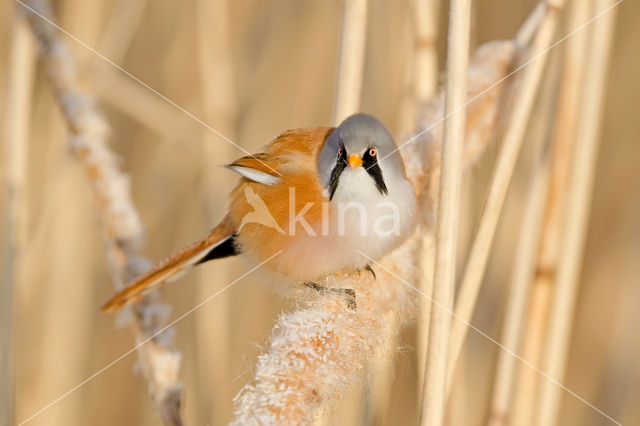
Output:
[[102, 113, 417, 312]]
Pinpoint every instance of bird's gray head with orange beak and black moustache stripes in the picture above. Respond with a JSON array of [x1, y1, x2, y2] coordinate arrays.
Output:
[[318, 114, 405, 198]]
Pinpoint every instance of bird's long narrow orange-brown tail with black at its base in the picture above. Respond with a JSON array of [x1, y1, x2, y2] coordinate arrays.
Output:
[[102, 220, 238, 312]]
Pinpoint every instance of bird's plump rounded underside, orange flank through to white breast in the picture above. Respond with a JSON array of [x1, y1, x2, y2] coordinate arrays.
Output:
[[232, 170, 415, 281]]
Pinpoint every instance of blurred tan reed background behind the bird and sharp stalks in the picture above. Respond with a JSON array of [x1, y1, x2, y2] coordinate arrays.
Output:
[[0, 0, 640, 425]]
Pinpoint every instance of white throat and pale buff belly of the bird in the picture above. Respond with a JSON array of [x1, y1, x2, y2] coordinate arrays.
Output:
[[282, 167, 416, 281]]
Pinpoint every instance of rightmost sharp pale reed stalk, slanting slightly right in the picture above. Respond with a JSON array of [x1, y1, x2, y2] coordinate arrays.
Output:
[[537, 0, 616, 425]]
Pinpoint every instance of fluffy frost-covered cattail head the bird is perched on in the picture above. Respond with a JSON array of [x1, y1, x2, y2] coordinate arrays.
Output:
[[234, 35, 514, 425]]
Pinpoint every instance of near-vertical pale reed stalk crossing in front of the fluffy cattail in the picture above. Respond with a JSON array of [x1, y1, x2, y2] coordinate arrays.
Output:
[[420, 0, 471, 426]]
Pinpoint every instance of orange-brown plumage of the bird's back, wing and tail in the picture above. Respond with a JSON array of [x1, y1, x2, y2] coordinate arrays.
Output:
[[102, 127, 334, 312]]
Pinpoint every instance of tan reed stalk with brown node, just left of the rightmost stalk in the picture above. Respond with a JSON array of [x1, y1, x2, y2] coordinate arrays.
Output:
[[512, 1, 590, 425]]
